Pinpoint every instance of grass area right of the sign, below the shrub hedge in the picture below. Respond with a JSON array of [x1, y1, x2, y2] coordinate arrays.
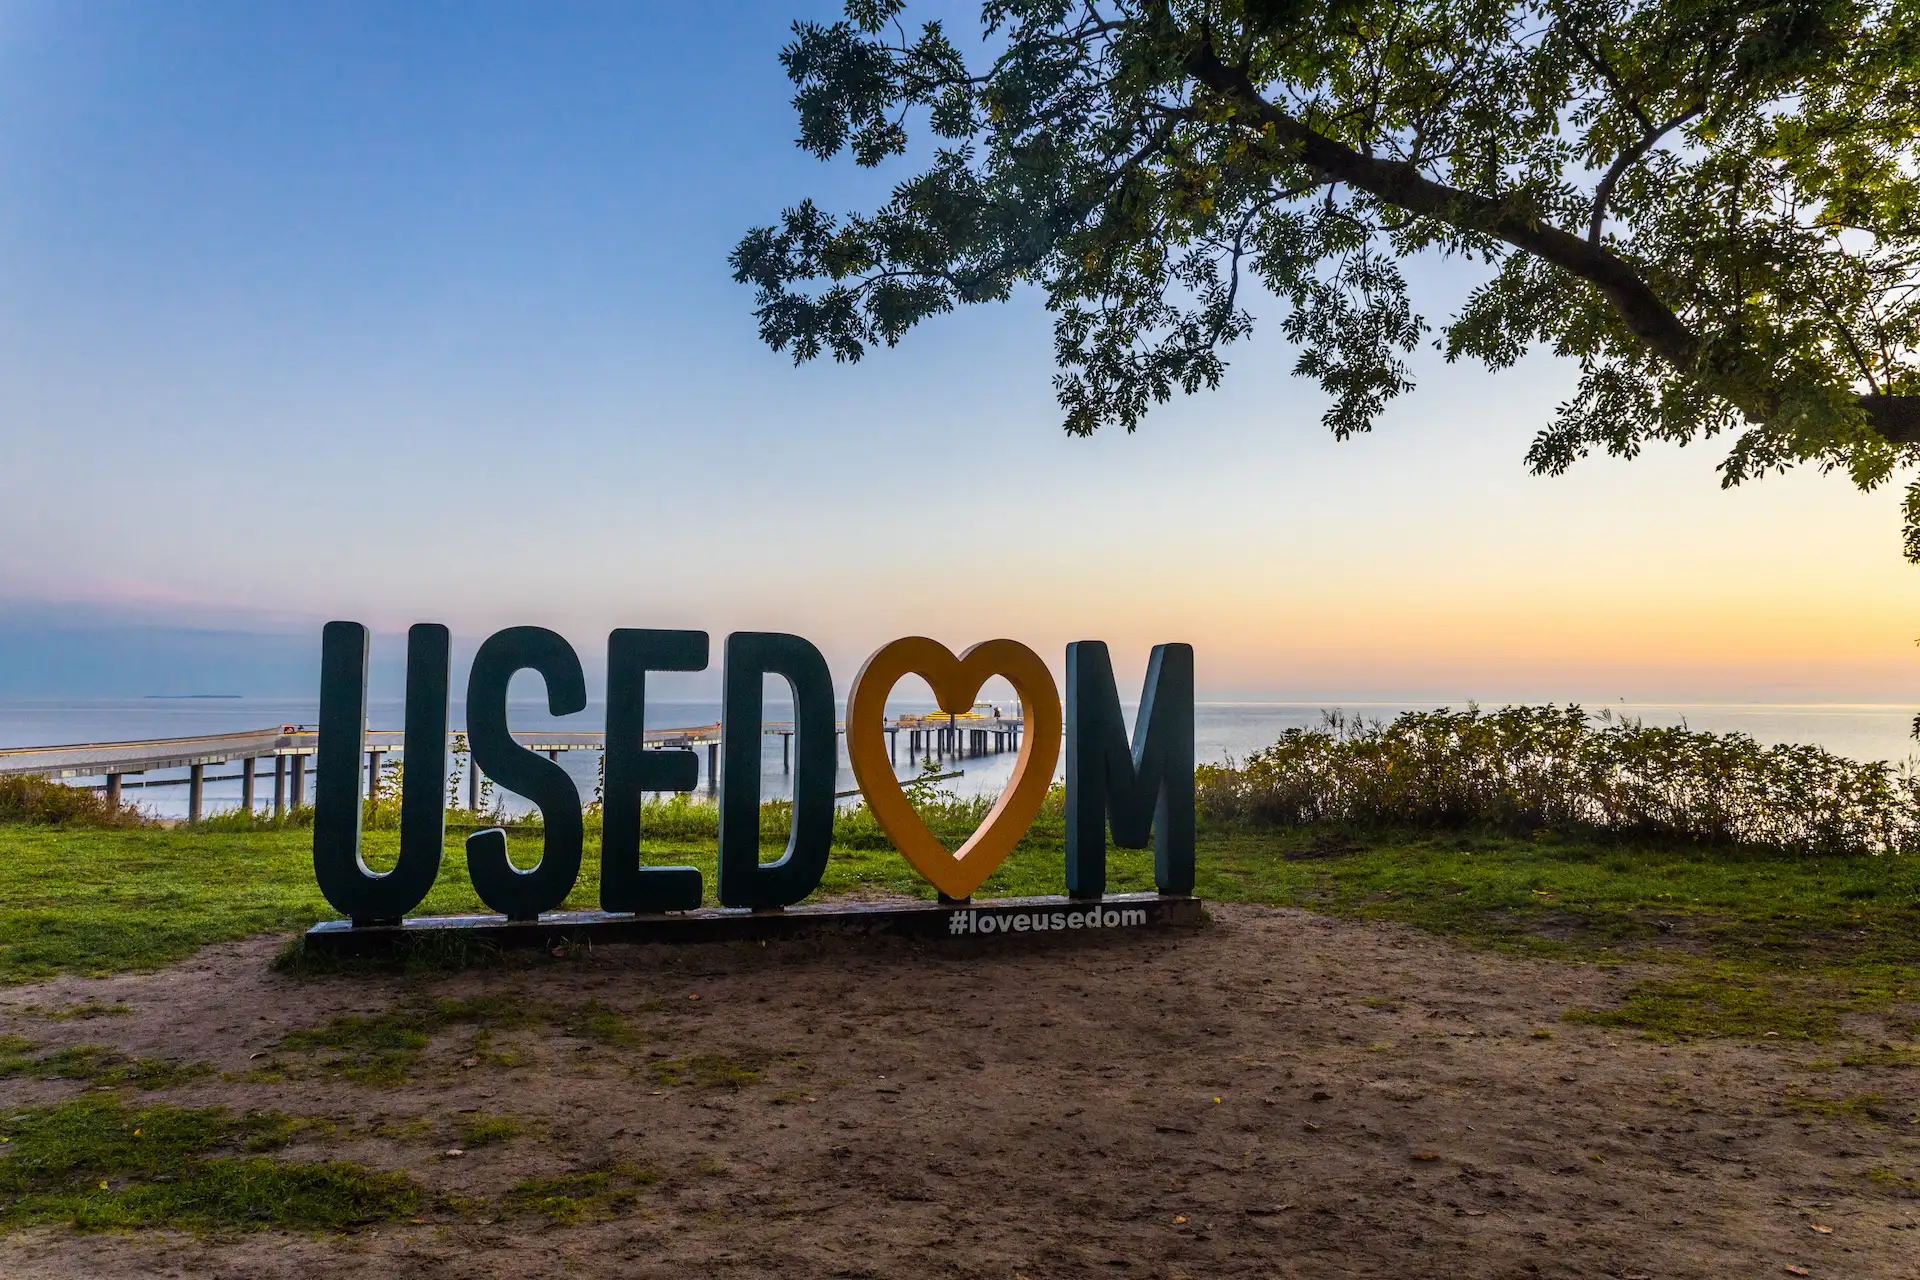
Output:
[[1198, 831, 1920, 1040]]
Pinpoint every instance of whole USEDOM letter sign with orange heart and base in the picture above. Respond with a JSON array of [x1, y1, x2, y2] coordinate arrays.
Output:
[[309, 622, 1198, 950]]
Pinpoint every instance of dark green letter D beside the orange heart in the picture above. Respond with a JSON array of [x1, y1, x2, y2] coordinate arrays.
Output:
[[720, 631, 839, 908]]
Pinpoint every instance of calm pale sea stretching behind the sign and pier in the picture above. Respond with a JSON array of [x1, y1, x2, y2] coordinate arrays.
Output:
[[0, 699, 1916, 818]]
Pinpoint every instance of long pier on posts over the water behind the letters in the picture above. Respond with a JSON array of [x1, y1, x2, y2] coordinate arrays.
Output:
[[0, 714, 1021, 821]]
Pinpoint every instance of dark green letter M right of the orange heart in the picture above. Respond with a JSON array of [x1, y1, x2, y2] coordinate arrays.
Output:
[[1068, 641, 1194, 898]]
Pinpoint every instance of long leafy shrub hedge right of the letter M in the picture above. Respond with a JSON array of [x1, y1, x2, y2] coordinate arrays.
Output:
[[1198, 706, 1920, 854]]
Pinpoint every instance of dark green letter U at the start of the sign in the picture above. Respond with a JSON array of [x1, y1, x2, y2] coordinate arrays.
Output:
[[313, 622, 447, 925]]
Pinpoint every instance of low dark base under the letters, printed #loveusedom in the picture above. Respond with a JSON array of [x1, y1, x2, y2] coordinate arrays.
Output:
[[307, 894, 1206, 956]]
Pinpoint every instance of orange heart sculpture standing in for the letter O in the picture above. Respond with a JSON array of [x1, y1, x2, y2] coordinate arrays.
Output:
[[847, 635, 1060, 898]]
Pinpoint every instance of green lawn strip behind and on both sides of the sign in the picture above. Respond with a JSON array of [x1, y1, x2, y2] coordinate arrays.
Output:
[[0, 819, 1920, 1036]]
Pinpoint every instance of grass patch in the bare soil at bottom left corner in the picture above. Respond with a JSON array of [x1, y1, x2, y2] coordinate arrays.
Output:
[[0, 1096, 420, 1232]]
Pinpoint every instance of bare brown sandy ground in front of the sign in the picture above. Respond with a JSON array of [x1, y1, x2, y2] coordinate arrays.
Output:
[[0, 908, 1920, 1280]]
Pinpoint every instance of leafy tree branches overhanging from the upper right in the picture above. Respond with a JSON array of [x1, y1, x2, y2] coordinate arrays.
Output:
[[732, 0, 1920, 545]]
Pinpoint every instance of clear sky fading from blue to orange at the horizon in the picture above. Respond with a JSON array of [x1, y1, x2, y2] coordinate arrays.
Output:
[[0, 0, 1920, 702]]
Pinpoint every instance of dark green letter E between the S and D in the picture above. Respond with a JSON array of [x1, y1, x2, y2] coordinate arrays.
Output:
[[601, 628, 707, 912]]
